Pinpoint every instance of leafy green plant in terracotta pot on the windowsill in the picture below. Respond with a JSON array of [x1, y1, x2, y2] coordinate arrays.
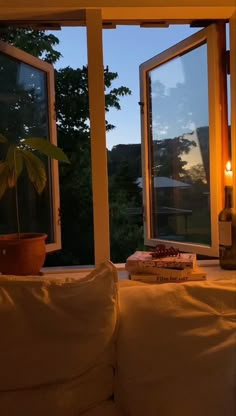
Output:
[[0, 134, 69, 275]]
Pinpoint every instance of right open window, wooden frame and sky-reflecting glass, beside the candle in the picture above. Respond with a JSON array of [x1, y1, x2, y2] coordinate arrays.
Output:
[[140, 24, 227, 256]]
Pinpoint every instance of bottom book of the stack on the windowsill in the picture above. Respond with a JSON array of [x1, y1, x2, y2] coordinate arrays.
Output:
[[130, 267, 206, 283]]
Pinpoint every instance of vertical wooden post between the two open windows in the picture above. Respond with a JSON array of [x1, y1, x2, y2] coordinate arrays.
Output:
[[86, 10, 110, 265]]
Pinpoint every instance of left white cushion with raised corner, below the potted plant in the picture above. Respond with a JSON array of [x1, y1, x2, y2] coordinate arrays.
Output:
[[0, 262, 117, 416]]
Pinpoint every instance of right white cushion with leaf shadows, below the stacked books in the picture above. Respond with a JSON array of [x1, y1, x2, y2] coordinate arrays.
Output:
[[115, 280, 236, 416]]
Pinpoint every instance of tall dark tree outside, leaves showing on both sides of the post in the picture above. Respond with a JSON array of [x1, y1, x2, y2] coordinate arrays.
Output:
[[1, 29, 131, 265]]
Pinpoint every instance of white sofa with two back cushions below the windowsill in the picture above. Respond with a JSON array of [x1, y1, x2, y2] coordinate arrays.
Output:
[[0, 262, 236, 416]]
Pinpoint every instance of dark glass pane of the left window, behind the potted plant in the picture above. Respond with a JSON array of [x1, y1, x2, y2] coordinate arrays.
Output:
[[0, 53, 54, 243]]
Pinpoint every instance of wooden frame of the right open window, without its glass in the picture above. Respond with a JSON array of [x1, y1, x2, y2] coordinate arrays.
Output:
[[140, 24, 224, 256]]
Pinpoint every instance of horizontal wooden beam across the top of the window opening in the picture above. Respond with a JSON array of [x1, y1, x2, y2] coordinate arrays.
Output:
[[0, 4, 236, 25]]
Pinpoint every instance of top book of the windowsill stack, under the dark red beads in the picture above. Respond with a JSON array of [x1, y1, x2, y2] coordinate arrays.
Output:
[[125, 251, 196, 274]]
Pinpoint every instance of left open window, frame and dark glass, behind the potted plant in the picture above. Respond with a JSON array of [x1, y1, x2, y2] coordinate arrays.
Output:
[[0, 42, 61, 251]]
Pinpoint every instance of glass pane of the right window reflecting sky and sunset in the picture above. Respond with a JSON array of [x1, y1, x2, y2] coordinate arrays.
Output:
[[147, 44, 211, 245]]
